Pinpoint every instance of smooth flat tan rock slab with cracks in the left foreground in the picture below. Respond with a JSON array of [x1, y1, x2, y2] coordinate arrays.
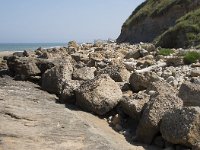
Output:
[[0, 77, 159, 150]]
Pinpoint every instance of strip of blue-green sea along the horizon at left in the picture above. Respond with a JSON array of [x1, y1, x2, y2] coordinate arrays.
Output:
[[0, 43, 67, 52]]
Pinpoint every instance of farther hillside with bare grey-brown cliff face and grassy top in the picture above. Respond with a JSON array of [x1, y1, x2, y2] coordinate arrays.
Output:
[[117, 0, 200, 48]]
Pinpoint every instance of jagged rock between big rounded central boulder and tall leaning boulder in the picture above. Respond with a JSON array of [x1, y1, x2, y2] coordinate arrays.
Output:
[[120, 91, 150, 121]]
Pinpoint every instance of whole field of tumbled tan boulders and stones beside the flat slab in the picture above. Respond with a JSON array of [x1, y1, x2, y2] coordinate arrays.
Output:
[[0, 41, 200, 150]]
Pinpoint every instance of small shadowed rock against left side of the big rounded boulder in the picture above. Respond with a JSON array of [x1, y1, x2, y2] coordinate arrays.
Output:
[[59, 80, 81, 104]]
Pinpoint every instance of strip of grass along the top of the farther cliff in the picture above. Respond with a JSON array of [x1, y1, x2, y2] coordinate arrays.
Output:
[[123, 0, 192, 28]]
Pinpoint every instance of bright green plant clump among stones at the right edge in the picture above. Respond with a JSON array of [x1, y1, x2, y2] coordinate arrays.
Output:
[[184, 51, 200, 64]]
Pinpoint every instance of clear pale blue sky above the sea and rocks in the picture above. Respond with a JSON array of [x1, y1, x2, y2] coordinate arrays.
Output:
[[0, 0, 144, 43]]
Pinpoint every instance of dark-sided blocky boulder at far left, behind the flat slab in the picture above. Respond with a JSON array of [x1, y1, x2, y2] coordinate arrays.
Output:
[[7, 56, 41, 78]]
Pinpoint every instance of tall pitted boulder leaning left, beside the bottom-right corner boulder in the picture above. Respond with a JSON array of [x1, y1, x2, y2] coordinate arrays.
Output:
[[136, 82, 183, 144]]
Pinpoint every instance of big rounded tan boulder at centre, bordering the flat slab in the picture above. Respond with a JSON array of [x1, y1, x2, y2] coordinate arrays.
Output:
[[76, 74, 122, 115]]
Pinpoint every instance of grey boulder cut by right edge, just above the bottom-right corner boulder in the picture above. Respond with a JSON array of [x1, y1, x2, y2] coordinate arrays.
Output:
[[178, 81, 200, 106]]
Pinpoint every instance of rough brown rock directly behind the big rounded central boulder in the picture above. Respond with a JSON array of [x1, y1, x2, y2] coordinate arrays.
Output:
[[96, 66, 130, 82]]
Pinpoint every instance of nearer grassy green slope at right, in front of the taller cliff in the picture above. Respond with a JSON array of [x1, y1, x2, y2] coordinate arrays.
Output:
[[156, 8, 200, 48]]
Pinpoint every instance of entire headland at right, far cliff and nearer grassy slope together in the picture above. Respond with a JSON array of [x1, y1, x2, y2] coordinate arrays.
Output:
[[117, 0, 200, 48]]
